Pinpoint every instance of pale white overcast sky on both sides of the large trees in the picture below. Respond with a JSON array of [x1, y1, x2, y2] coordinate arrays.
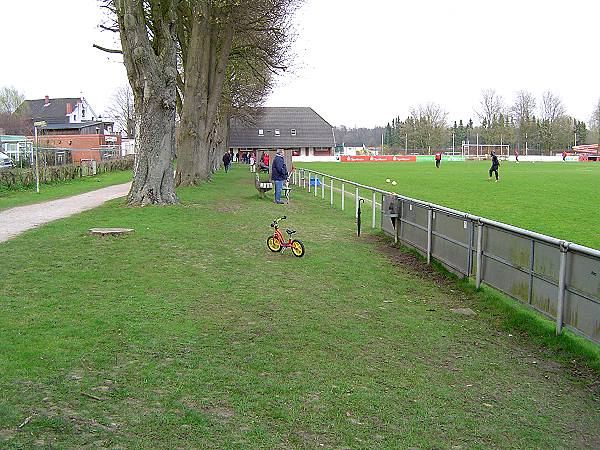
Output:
[[0, 0, 600, 127]]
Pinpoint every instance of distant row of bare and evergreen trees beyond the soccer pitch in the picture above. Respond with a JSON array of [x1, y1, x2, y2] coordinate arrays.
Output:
[[384, 89, 600, 153]]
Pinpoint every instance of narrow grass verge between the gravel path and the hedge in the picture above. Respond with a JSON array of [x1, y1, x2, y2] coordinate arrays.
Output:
[[0, 170, 132, 210]]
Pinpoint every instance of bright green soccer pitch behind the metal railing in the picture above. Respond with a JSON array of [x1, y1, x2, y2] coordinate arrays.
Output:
[[295, 160, 600, 248]]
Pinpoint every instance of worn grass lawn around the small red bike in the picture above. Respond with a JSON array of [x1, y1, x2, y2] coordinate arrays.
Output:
[[0, 166, 600, 448]]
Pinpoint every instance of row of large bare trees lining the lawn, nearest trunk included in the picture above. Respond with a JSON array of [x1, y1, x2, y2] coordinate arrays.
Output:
[[96, 0, 298, 205]]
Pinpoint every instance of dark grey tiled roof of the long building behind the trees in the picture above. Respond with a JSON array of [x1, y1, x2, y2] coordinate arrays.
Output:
[[229, 107, 335, 148]]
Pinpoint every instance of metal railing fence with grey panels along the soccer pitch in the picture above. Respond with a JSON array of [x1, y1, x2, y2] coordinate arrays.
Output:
[[292, 168, 600, 344]]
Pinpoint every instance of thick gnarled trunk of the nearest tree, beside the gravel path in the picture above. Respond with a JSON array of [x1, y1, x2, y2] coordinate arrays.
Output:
[[110, 0, 179, 206]]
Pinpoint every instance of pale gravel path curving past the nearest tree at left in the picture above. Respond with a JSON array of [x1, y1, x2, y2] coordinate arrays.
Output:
[[0, 183, 131, 242]]
